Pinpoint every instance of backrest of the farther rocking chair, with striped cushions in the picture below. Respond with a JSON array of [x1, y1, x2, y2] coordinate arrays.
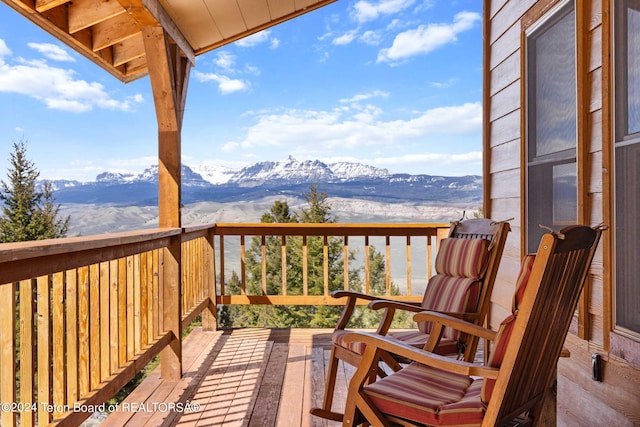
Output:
[[418, 218, 511, 360]]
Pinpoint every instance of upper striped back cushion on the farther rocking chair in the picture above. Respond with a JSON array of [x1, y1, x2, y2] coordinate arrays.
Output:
[[436, 237, 490, 279]]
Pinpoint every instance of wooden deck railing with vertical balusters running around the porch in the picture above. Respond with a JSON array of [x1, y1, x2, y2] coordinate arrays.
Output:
[[0, 224, 448, 426]]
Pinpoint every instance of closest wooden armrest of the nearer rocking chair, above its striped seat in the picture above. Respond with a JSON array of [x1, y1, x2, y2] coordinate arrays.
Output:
[[344, 332, 499, 379]]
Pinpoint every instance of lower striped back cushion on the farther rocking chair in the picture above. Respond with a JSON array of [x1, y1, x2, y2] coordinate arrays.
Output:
[[418, 274, 480, 340]]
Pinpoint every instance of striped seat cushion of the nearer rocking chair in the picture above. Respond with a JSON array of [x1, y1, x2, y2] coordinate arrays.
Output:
[[364, 363, 486, 426]]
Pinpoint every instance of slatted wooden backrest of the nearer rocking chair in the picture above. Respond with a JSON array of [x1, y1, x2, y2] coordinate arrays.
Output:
[[483, 226, 603, 425]]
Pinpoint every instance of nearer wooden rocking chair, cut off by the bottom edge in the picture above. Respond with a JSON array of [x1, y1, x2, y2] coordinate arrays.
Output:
[[343, 226, 603, 426]]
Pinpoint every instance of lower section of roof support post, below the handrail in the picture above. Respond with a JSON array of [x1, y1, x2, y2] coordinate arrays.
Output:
[[160, 236, 182, 380]]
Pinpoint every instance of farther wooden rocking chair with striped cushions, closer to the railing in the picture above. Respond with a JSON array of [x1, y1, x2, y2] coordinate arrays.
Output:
[[311, 218, 510, 421]]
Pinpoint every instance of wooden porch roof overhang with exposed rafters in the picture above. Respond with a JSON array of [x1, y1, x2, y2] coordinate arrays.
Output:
[[2, 0, 336, 82]]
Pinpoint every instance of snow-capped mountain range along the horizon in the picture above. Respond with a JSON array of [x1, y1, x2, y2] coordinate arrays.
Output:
[[51, 157, 482, 206]]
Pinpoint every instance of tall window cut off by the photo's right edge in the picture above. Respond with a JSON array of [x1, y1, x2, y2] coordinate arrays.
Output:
[[614, 0, 640, 333]]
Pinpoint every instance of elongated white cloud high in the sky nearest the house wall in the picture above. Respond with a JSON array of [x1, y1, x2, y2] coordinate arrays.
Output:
[[377, 12, 481, 63]]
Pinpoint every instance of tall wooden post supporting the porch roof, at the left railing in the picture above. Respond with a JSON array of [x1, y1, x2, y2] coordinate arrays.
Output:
[[142, 25, 192, 379]]
